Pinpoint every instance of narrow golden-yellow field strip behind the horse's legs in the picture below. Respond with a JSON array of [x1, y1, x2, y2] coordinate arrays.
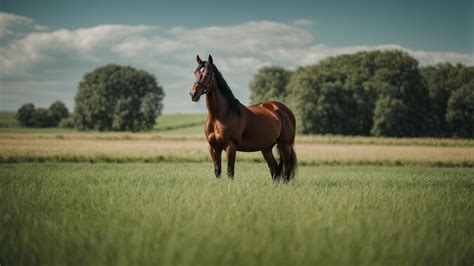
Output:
[[0, 133, 474, 167]]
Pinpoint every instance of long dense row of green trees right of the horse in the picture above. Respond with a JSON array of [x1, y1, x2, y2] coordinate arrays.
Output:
[[250, 50, 474, 137]]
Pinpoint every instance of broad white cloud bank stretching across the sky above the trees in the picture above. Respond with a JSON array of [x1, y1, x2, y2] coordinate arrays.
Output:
[[0, 13, 474, 112]]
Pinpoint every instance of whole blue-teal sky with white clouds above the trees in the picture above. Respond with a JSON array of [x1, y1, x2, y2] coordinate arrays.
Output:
[[0, 0, 474, 113]]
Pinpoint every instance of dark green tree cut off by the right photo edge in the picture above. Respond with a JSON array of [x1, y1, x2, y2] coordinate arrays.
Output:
[[446, 82, 474, 138]]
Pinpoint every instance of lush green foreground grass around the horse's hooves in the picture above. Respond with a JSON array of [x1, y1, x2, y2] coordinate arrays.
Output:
[[0, 162, 474, 265]]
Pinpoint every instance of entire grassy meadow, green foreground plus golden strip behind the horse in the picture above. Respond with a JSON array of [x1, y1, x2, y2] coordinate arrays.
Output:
[[0, 111, 474, 265]]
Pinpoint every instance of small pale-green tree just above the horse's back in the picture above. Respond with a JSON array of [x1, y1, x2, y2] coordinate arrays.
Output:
[[250, 66, 291, 103]]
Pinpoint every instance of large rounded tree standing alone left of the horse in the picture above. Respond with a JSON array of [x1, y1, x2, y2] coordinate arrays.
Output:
[[75, 64, 164, 131]]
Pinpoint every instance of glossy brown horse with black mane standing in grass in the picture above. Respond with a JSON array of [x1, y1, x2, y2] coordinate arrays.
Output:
[[189, 55, 296, 182]]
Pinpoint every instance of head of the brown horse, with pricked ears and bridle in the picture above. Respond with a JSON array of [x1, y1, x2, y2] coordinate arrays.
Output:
[[189, 55, 214, 102]]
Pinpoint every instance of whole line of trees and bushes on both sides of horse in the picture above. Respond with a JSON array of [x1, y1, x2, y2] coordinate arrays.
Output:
[[16, 50, 474, 137]]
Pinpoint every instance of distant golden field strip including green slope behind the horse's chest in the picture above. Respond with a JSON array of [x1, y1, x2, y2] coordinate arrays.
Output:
[[0, 110, 474, 167]]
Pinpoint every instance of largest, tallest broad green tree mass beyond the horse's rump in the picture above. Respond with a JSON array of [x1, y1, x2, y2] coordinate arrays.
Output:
[[287, 50, 430, 136]]
